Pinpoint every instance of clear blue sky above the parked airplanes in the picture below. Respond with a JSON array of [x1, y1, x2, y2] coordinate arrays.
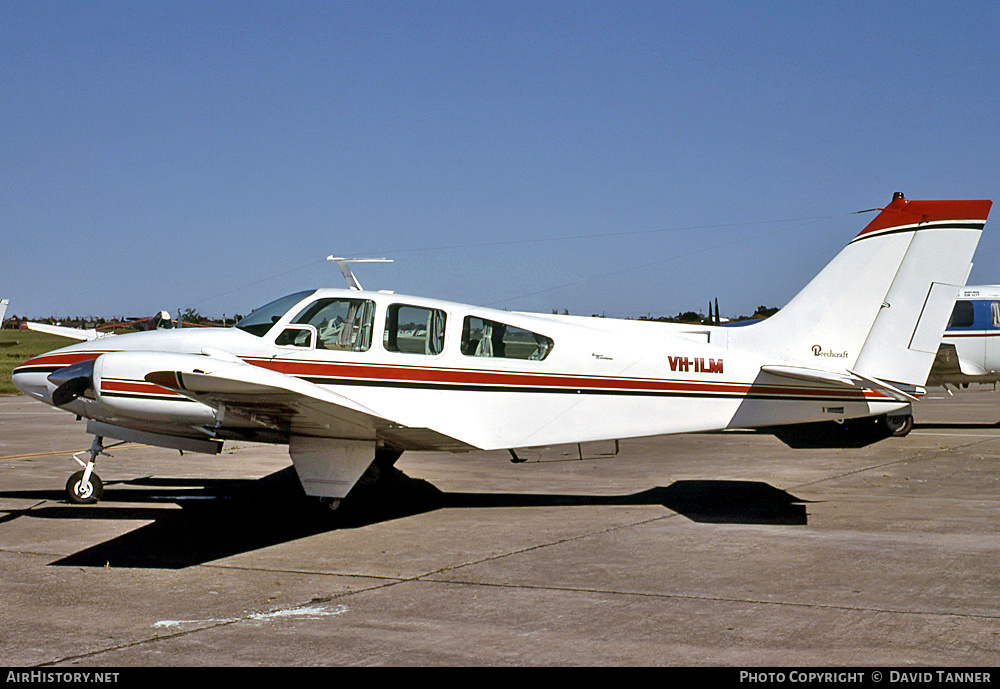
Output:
[[0, 0, 1000, 317]]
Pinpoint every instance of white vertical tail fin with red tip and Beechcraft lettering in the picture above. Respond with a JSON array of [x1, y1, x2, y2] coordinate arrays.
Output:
[[729, 193, 992, 385]]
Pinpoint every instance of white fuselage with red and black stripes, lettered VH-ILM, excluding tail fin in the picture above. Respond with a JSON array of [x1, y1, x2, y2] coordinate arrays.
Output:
[[14, 289, 906, 449]]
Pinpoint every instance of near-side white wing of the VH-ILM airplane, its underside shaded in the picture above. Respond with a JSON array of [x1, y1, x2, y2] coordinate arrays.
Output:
[[145, 355, 477, 452]]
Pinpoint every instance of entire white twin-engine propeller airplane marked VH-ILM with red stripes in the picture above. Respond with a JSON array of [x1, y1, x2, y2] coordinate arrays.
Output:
[[7, 194, 992, 505]]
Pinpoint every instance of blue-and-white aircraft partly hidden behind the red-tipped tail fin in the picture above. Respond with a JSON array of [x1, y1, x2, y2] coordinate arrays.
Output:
[[927, 285, 1000, 387]]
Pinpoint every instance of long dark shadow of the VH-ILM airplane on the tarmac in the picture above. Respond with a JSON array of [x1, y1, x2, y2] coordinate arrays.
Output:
[[0, 467, 806, 569]]
